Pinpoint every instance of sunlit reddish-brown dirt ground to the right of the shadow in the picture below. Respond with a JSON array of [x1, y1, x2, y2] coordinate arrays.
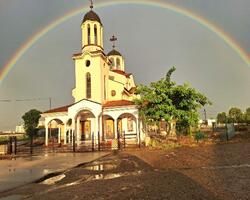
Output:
[[130, 142, 250, 200]]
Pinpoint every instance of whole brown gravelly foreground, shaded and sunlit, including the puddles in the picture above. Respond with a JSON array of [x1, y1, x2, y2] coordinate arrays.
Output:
[[0, 142, 250, 200]]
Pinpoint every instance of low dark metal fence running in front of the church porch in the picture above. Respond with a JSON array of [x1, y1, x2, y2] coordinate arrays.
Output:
[[0, 132, 140, 155]]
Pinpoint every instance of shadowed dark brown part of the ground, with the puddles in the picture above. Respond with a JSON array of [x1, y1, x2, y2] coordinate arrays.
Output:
[[0, 153, 217, 200]]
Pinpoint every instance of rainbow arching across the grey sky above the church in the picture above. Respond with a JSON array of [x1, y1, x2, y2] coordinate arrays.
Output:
[[0, 0, 250, 83]]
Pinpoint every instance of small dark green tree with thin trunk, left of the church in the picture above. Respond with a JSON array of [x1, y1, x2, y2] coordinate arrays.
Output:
[[22, 109, 41, 154]]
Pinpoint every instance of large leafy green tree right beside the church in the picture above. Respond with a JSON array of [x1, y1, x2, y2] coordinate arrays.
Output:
[[135, 67, 210, 134]]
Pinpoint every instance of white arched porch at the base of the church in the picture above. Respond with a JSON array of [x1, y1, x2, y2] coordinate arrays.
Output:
[[42, 100, 143, 149]]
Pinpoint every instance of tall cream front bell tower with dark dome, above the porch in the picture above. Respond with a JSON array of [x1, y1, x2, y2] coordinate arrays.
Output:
[[72, 1, 108, 103]]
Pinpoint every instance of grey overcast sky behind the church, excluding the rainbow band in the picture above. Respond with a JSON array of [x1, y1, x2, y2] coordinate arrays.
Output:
[[0, 0, 250, 131]]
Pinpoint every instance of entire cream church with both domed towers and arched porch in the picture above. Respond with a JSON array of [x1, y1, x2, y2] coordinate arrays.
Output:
[[42, 3, 144, 146]]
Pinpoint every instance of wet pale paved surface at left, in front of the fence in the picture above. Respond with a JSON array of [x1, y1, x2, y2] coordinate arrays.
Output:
[[0, 152, 108, 192]]
